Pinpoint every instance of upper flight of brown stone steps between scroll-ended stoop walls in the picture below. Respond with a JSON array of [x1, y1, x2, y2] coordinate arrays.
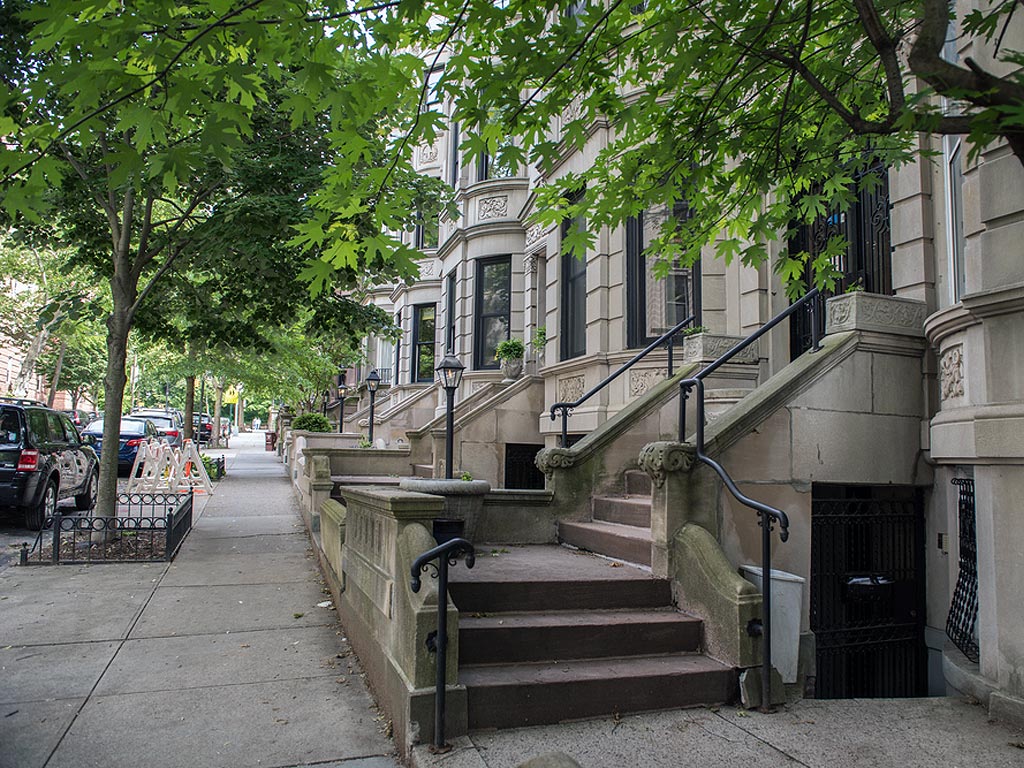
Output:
[[558, 469, 651, 566]]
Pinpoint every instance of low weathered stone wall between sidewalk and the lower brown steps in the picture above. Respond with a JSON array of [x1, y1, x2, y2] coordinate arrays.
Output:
[[327, 486, 468, 756]]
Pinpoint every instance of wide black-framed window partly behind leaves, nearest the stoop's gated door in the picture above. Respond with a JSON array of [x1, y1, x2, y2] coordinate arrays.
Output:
[[626, 201, 700, 347]]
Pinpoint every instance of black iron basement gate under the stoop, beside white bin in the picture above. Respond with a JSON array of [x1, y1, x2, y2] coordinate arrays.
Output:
[[810, 484, 928, 698]]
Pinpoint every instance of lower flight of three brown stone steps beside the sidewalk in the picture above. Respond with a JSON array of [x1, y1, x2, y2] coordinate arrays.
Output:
[[450, 546, 736, 729]]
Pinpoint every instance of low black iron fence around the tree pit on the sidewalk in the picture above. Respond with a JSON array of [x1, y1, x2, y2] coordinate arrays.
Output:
[[20, 490, 193, 565]]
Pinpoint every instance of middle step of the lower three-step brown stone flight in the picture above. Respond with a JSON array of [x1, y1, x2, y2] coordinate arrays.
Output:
[[459, 608, 701, 665]]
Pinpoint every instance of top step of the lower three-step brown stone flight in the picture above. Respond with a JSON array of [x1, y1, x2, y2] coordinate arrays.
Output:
[[449, 578, 672, 613]]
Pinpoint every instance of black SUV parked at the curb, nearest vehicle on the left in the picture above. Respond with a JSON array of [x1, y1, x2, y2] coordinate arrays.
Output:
[[0, 397, 99, 530]]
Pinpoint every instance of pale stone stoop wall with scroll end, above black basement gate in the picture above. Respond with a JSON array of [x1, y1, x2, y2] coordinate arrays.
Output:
[[640, 294, 944, 688]]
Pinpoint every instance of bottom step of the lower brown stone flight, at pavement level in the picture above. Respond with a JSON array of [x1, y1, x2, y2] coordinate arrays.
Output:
[[459, 654, 736, 729]]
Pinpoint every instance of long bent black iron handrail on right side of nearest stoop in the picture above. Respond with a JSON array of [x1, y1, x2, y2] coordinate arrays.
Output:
[[679, 289, 821, 712]]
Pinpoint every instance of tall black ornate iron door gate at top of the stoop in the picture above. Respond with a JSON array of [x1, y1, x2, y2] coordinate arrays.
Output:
[[790, 163, 893, 359]]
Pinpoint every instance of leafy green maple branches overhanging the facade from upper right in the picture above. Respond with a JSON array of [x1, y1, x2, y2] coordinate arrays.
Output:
[[406, 0, 1024, 288]]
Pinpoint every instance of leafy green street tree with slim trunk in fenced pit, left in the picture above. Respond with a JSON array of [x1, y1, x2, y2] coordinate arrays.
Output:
[[0, 0, 448, 514]]
